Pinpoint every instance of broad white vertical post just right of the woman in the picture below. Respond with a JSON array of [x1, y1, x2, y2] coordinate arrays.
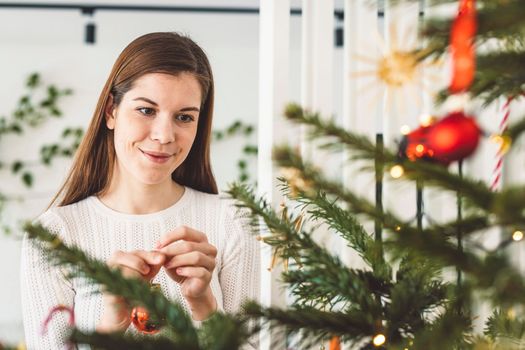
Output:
[[257, 0, 290, 350]]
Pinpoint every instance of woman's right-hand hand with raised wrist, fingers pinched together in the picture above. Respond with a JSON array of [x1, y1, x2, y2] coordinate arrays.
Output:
[[157, 226, 217, 320]]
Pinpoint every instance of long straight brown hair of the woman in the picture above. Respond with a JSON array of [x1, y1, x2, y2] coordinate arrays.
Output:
[[50, 32, 218, 206]]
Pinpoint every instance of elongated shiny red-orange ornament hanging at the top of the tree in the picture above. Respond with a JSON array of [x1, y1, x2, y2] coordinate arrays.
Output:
[[449, 0, 478, 93]]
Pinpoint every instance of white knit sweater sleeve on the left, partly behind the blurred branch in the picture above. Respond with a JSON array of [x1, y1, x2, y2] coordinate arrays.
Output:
[[20, 211, 75, 350]]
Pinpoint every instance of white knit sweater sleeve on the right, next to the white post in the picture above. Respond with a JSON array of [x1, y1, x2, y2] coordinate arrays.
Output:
[[219, 205, 260, 349]]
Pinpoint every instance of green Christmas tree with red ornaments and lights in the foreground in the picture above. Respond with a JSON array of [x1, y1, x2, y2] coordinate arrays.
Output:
[[14, 0, 525, 349]]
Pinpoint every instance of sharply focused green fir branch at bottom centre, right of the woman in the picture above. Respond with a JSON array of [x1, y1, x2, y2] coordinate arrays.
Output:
[[229, 183, 452, 349]]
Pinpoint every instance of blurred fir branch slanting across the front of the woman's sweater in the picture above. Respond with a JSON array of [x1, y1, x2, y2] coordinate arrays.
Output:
[[24, 223, 198, 349]]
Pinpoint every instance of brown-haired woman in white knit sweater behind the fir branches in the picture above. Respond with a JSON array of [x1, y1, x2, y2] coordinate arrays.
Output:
[[21, 33, 259, 349]]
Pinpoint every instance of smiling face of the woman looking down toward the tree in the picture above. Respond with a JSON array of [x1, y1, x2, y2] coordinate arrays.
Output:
[[106, 73, 201, 185]]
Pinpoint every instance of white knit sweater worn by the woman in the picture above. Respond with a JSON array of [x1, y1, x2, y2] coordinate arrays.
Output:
[[21, 187, 260, 350]]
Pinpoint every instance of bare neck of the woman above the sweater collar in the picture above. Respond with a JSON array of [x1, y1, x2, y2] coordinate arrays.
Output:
[[99, 169, 184, 215]]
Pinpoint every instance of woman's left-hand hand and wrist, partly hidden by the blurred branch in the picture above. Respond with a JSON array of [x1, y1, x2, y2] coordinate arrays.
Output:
[[97, 250, 166, 332]]
